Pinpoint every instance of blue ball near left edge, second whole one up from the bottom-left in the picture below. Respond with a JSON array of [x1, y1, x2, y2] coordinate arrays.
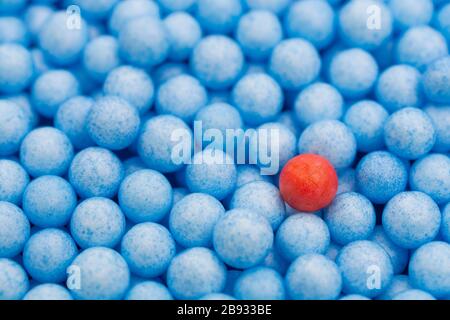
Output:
[[22, 176, 77, 228]]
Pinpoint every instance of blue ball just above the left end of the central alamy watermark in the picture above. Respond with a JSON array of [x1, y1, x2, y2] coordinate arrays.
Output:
[[156, 75, 208, 123]]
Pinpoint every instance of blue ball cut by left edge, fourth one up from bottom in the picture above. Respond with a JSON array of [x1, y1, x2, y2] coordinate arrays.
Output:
[[0, 99, 31, 156]]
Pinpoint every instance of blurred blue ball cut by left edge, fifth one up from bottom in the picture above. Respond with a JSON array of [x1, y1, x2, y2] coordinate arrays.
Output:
[[0, 43, 34, 94]]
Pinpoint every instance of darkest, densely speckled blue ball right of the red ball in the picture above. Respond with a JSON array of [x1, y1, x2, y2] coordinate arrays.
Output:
[[356, 151, 408, 204]]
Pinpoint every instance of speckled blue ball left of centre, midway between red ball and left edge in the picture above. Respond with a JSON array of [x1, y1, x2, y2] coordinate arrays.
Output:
[[118, 169, 173, 223]]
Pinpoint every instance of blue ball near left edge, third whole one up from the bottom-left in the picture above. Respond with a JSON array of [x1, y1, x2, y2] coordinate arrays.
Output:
[[20, 127, 73, 177]]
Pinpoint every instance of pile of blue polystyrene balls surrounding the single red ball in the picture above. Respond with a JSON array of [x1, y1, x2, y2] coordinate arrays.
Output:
[[0, 0, 450, 300]]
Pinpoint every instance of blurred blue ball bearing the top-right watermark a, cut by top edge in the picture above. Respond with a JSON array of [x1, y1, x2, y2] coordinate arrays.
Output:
[[338, 0, 393, 50]]
